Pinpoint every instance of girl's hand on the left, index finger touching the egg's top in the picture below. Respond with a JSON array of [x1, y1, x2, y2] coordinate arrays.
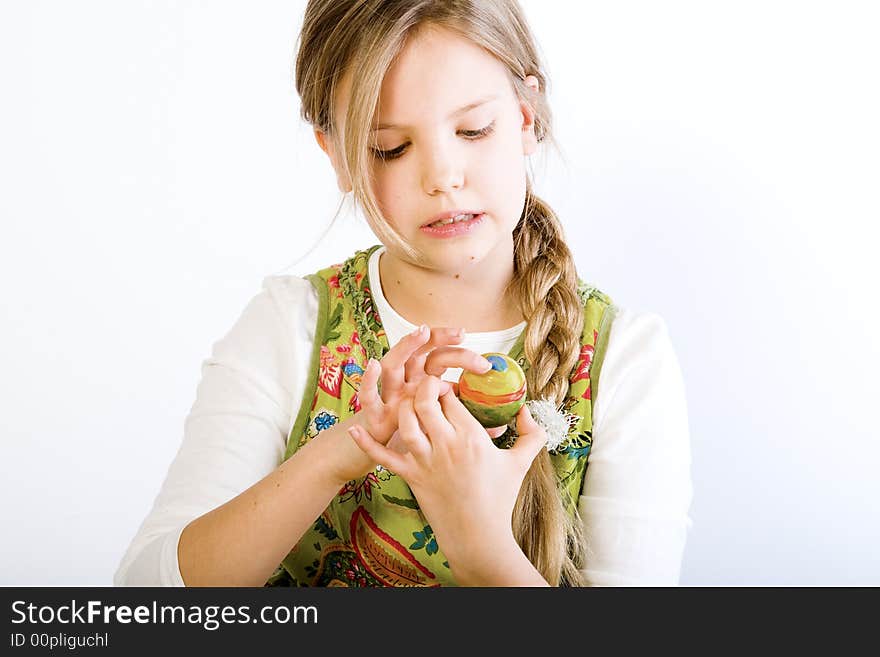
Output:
[[337, 326, 492, 481]]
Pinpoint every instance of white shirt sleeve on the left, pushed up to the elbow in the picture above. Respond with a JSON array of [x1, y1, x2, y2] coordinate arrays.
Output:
[[113, 276, 317, 586]]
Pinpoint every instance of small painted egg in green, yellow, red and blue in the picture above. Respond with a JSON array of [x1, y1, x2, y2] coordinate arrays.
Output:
[[458, 352, 526, 428]]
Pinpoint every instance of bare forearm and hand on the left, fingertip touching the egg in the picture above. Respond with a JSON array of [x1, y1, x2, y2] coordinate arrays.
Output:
[[178, 328, 491, 586]]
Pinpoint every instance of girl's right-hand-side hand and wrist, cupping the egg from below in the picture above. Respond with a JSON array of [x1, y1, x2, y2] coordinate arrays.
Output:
[[349, 376, 547, 581]]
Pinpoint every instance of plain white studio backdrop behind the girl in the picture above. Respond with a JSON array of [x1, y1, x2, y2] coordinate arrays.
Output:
[[0, 0, 880, 586]]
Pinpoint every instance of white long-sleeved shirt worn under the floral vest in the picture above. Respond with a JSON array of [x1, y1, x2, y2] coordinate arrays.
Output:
[[113, 247, 693, 586]]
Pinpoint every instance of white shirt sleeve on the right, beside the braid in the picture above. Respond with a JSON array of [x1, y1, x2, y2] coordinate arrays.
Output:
[[578, 309, 693, 586]]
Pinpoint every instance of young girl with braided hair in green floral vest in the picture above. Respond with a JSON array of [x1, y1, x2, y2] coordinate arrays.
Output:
[[114, 0, 691, 586]]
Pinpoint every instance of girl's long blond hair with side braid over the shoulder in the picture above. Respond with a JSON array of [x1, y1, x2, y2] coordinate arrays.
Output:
[[296, 0, 586, 586]]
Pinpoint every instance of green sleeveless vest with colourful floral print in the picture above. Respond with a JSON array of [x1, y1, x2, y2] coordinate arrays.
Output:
[[266, 245, 616, 586]]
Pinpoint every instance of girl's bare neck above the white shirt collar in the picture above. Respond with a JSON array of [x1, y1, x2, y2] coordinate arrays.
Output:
[[379, 242, 523, 333]]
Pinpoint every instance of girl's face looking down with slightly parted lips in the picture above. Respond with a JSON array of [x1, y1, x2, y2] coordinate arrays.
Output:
[[326, 27, 538, 271]]
